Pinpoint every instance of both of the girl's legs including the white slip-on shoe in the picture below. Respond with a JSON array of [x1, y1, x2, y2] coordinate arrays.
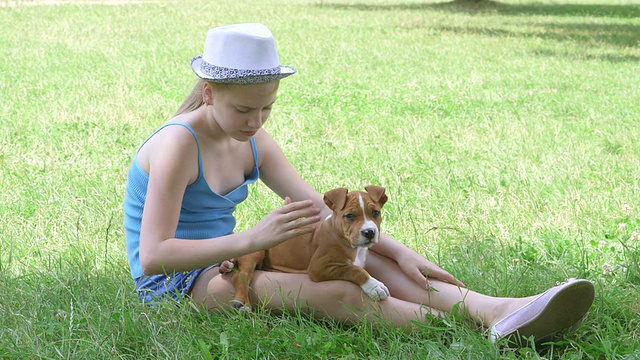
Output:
[[191, 252, 594, 341]]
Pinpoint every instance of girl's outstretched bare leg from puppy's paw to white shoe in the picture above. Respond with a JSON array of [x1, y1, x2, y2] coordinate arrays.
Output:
[[366, 251, 534, 327]]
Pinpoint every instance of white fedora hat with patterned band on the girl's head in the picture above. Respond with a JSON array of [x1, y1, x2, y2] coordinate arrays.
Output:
[[191, 23, 296, 84]]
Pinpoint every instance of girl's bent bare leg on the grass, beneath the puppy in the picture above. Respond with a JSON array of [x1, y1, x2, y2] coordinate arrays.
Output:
[[191, 268, 439, 327]]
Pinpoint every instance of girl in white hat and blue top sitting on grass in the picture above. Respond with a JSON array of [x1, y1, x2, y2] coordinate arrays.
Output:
[[124, 24, 594, 342]]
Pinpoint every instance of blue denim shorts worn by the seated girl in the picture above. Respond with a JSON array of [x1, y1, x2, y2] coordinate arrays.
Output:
[[135, 263, 220, 304]]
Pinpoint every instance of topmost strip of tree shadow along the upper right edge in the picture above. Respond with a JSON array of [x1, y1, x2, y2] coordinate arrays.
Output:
[[314, 0, 640, 19]]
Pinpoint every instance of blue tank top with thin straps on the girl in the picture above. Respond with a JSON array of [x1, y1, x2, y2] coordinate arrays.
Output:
[[124, 122, 260, 279]]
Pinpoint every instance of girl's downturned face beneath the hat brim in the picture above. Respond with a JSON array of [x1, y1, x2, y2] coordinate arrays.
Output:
[[205, 81, 279, 141]]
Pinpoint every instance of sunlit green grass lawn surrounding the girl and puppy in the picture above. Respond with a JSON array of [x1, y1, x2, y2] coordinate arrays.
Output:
[[0, 0, 640, 359]]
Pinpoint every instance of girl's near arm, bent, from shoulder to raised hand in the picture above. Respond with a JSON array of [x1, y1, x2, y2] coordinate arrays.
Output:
[[140, 128, 319, 275]]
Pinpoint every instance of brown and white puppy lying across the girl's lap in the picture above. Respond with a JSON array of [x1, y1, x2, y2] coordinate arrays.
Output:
[[231, 185, 389, 310]]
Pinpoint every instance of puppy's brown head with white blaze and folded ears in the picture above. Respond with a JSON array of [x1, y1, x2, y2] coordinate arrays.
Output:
[[324, 185, 387, 248]]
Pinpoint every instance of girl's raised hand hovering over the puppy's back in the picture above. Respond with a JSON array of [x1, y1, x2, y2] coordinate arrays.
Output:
[[253, 197, 320, 249]]
